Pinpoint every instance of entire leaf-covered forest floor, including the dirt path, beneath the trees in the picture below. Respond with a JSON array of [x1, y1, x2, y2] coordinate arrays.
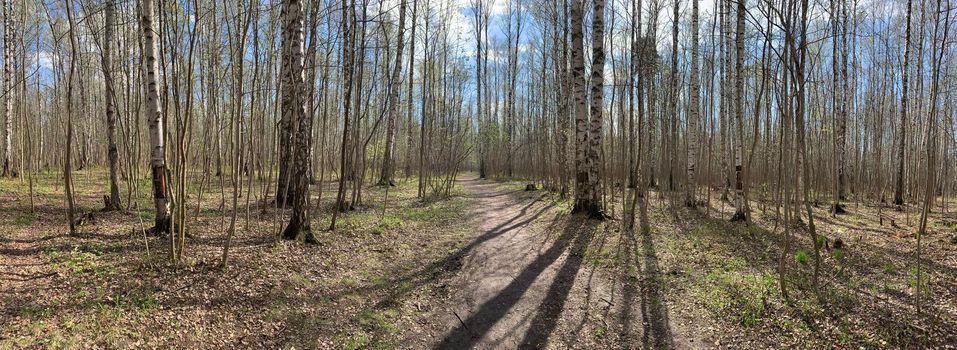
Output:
[[0, 170, 957, 349]]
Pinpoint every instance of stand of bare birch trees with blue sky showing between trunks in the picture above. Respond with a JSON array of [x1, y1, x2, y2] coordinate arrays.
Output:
[[0, 0, 957, 270]]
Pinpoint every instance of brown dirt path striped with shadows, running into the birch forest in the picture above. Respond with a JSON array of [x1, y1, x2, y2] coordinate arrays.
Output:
[[432, 179, 693, 349]]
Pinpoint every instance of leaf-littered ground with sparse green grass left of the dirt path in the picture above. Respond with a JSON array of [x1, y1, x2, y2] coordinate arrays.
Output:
[[0, 170, 468, 348]]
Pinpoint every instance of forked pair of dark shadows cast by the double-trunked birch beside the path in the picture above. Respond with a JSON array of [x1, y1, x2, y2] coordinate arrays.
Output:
[[433, 217, 595, 349]]
